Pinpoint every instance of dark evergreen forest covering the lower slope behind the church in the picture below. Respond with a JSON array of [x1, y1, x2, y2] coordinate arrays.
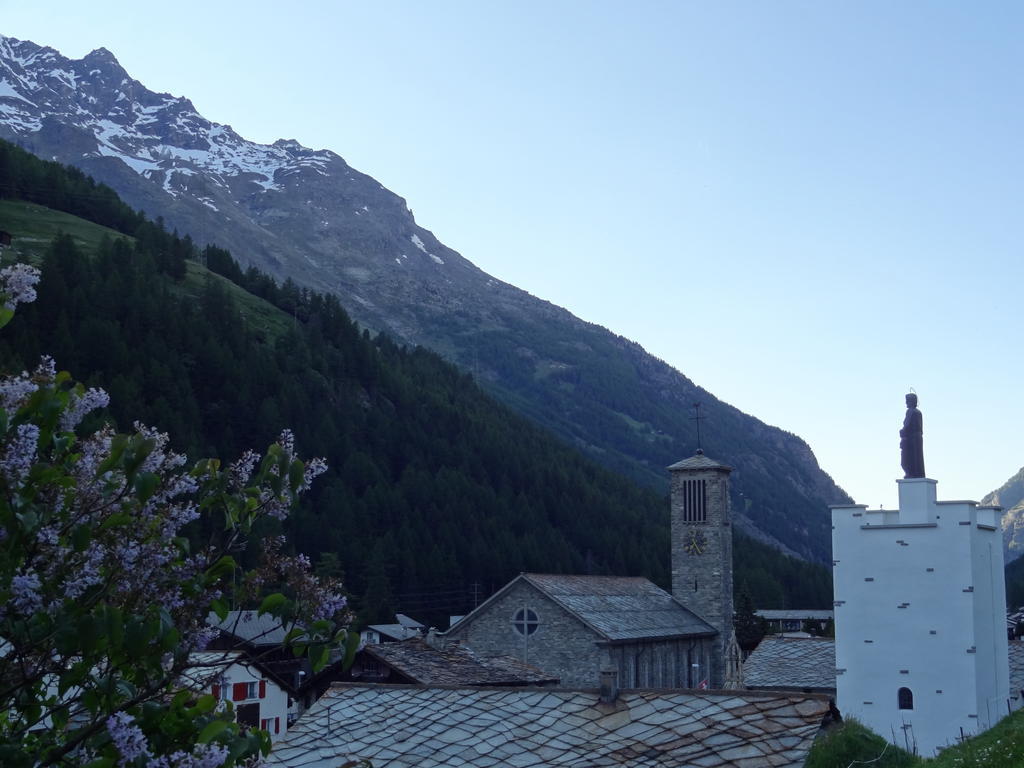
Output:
[[0, 142, 831, 627]]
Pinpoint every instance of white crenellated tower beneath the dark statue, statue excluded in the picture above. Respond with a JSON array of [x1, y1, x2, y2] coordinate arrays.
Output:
[[831, 478, 1009, 756]]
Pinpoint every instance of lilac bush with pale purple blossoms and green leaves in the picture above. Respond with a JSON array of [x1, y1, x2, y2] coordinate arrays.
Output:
[[0, 264, 352, 768]]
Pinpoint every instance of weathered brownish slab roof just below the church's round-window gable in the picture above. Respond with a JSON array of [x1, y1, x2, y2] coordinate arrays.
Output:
[[362, 638, 558, 685]]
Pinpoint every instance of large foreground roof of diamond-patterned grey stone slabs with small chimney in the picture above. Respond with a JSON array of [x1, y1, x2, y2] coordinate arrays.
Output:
[[267, 685, 828, 768]]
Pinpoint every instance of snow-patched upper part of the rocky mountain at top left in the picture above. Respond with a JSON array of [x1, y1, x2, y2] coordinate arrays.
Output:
[[0, 37, 349, 198]]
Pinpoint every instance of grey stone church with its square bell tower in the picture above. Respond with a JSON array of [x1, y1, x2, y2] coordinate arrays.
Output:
[[442, 451, 732, 688]]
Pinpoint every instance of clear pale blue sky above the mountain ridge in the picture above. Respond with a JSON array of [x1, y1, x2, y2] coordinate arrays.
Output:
[[0, 0, 1024, 507]]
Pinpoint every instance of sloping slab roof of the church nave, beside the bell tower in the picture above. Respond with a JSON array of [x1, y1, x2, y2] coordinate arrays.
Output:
[[522, 573, 715, 642]]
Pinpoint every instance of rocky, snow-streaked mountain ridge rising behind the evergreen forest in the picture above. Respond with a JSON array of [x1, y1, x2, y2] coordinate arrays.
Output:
[[0, 38, 849, 560]]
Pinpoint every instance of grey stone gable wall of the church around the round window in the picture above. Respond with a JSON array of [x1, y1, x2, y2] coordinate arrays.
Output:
[[445, 581, 609, 688]]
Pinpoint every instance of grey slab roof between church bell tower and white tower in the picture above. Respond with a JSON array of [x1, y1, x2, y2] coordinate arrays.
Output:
[[743, 635, 836, 691]]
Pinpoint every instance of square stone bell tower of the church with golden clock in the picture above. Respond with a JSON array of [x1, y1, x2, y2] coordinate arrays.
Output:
[[669, 450, 732, 688]]
